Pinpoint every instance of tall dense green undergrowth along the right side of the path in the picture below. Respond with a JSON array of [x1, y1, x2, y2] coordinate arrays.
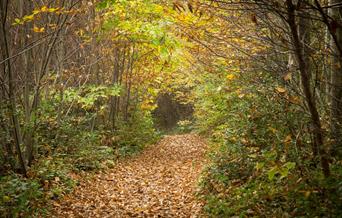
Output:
[[193, 67, 342, 217]]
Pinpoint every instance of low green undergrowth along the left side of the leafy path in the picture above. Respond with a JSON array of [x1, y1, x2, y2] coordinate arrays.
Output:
[[0, 98, 160, 217]]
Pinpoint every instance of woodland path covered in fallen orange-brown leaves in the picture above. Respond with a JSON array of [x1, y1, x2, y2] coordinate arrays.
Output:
[[53, 134, 206, 218]]
